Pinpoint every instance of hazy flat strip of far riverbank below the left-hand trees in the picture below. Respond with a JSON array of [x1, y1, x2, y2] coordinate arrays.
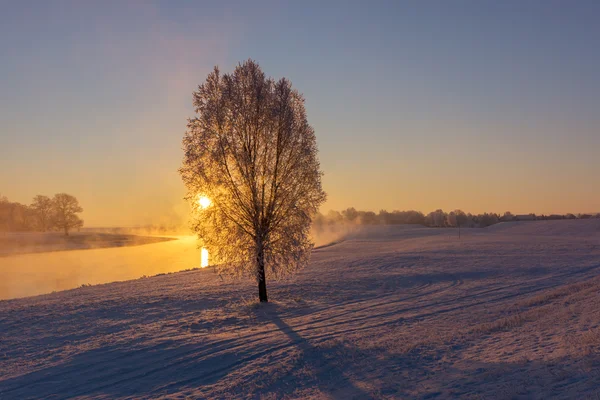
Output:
[[0, 232, 172, 256]]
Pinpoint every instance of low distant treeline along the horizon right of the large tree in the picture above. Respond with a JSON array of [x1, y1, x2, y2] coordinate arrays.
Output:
[[314, 207, 600, 228]]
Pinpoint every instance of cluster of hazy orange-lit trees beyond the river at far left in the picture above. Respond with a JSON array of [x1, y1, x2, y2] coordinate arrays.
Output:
[[0, 193, 83, 235]]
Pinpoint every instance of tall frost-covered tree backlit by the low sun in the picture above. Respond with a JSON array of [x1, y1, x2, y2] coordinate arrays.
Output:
[[180, 60, 325, 302]]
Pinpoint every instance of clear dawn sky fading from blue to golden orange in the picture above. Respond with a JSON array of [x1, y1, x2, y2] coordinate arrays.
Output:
[[0, 0, 600, 226]]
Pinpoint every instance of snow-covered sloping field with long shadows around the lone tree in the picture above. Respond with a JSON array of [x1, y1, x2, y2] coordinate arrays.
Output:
[[0, 220, 600, 399]]
